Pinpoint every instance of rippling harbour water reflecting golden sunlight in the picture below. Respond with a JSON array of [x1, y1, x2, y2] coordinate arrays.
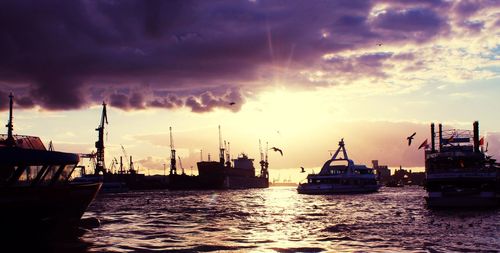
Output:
[[80, 187, 500, 252]]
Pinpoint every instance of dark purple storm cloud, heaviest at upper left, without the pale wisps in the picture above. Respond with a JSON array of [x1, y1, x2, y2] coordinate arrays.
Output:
[[0, 0, 494, 112]]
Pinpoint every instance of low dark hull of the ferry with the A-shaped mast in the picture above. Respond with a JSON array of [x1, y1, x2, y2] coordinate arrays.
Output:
[[297, 184, 380, 194]]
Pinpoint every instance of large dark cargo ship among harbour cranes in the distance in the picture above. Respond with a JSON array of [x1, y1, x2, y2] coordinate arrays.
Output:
[[169, 126, 269, 190]]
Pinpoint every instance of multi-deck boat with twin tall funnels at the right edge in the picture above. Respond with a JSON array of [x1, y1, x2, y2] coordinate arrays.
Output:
[[425, 121, 500, 208]]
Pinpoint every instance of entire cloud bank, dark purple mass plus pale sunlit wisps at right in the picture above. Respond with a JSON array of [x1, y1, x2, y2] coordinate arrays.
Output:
[[0, 0, 500, 110]]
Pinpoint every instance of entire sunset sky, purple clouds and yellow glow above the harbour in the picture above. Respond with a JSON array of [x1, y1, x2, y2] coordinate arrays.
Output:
[[0, 0, 500, 181]]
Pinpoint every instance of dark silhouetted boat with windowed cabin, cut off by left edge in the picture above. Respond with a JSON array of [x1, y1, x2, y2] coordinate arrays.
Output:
[[0, 95, 101, 229]]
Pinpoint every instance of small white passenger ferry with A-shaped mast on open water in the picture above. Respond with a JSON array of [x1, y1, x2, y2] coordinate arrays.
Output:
[[297, 139, 380, 194]]
